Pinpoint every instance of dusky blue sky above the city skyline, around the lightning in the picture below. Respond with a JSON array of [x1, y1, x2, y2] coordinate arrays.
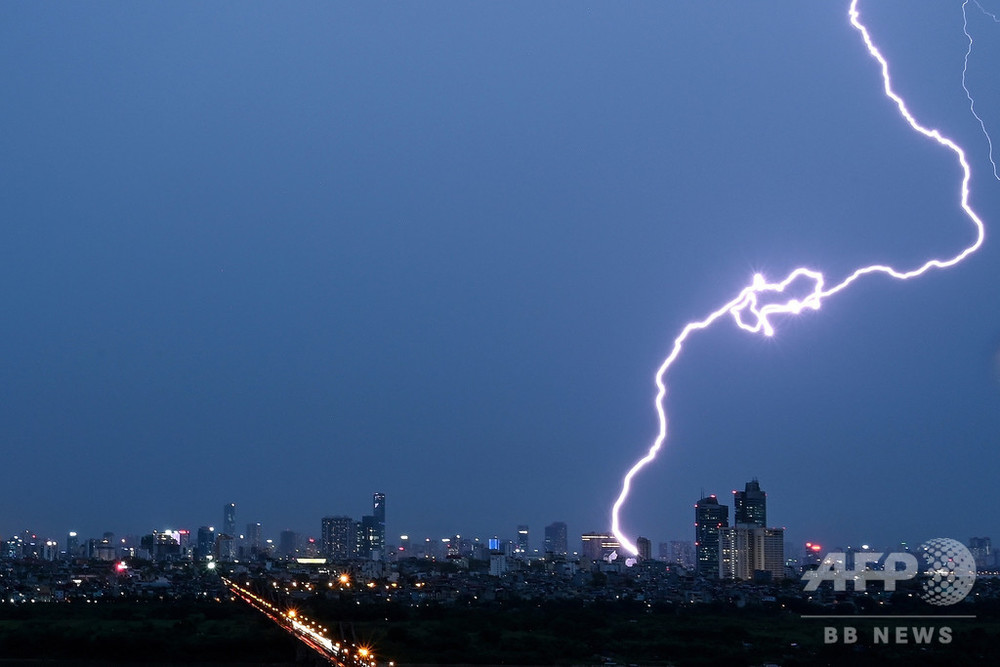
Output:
[[0, 1, 1000, 543]]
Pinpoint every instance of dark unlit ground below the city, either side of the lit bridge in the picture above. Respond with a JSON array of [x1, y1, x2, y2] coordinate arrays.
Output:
[[0, 600, 1000, 667]]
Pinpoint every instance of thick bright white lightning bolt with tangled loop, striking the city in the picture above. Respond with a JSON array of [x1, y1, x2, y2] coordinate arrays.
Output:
[[611, 0, 989, 555]]
